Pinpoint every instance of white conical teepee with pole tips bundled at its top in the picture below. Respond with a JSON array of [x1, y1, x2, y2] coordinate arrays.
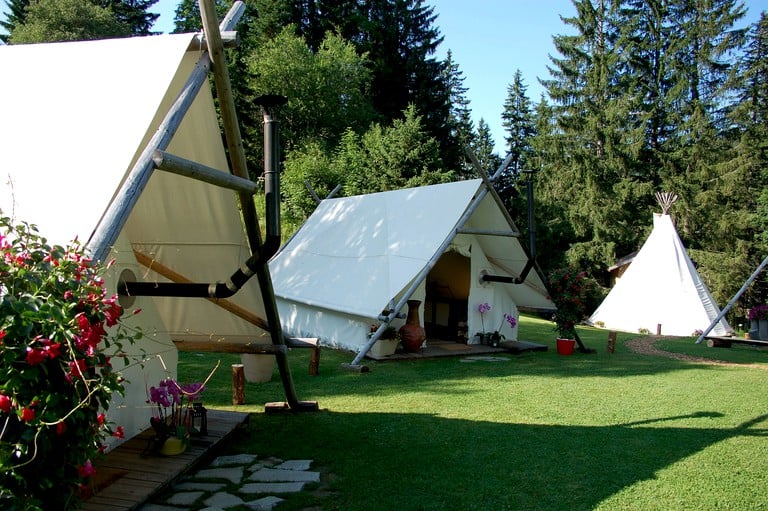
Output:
[[589, 193, 731, 337]]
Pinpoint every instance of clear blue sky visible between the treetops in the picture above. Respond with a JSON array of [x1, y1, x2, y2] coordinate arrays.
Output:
[[6, 0, 768, 155]]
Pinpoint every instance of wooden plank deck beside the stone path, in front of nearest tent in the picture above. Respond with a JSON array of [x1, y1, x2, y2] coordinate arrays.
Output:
[[83, 410, 249, 511]]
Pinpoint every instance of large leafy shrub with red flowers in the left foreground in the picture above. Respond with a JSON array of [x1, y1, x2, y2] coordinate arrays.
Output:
[[0, 215, 140, 510]]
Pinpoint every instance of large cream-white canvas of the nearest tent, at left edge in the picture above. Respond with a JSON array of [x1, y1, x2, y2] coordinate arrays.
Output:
[[0, 28, 280, 444]]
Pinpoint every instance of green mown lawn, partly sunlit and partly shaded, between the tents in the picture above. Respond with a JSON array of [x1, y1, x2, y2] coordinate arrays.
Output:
[[179, 317, 768, 511]]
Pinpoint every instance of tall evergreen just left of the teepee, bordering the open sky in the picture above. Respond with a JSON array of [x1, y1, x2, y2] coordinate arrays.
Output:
[[543, 0, 653, 274]]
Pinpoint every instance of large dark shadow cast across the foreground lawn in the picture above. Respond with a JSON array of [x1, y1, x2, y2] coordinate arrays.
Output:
[[235, 411, 768, 511]]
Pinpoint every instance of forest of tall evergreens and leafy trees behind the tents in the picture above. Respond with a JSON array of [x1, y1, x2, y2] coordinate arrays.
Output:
[[0, 0, 768, 324]]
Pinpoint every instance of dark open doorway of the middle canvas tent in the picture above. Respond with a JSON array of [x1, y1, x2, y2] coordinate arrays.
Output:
[[424, 252, 471, 342]]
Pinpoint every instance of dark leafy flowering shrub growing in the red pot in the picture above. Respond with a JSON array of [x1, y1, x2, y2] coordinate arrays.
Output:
[[548, 266, 588, 339]]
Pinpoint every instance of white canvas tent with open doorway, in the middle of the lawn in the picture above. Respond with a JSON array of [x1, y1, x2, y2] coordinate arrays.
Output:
[[270, 179, 554, 360]]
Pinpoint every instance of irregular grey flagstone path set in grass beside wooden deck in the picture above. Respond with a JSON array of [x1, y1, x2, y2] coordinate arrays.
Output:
[[139, 454, 320, 511]]
